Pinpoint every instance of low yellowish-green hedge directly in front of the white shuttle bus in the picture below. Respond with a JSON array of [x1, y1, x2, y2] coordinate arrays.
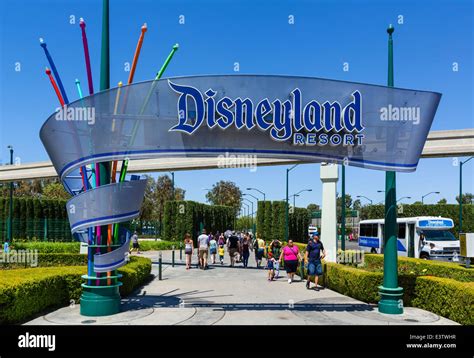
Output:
[[364, 254, 474, 282]]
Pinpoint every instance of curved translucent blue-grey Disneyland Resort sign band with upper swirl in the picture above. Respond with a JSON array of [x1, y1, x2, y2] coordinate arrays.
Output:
[[40, 75, 441, 268]]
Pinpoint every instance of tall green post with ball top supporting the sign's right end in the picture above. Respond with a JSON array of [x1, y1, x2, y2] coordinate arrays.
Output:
[[378, 25, 403, 314]]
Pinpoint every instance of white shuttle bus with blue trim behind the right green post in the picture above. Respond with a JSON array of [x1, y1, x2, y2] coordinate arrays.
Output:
[[359, 216, 460, 261]]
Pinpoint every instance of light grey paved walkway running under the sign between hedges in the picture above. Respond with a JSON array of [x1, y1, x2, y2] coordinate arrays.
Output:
[[26, 251, 456, 325]]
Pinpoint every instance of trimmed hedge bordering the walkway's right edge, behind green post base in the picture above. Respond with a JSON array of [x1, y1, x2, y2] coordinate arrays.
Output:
[[321, 262, 474, 325]]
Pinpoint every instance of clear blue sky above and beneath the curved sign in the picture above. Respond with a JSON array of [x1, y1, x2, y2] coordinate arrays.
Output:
[[0, 0, 474, 206]]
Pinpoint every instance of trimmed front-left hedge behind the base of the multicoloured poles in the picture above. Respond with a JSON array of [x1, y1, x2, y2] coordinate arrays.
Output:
[[0, 257, 151, 324]]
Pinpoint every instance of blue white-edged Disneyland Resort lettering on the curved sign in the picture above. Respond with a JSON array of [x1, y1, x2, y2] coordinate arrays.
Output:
[[168, 81, 364, 146]]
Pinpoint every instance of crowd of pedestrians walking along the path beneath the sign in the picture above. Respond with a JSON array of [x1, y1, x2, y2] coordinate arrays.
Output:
[[184, 229, 326, 290]]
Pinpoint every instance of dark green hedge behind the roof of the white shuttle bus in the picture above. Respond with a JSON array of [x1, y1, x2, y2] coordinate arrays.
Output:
[[360, 204, 474, 237]]
